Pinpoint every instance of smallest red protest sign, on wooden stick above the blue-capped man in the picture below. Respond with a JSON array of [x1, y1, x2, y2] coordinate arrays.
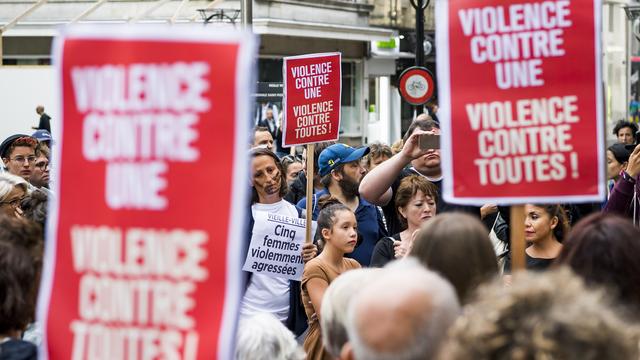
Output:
[[282, 53, 342, 146]]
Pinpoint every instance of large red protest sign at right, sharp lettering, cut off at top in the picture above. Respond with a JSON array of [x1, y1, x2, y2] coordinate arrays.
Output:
[[436, 0, 604, 204]]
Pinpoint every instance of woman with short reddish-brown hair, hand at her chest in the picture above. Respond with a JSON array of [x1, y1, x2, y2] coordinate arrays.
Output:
[[371, 175, 438, 267]]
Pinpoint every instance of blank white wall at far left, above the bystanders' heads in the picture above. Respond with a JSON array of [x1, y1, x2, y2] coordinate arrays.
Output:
[[0, 66, 60, 142]]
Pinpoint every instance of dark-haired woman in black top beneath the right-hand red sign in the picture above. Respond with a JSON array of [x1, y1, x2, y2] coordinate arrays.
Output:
[[504, 204, 569, 272]]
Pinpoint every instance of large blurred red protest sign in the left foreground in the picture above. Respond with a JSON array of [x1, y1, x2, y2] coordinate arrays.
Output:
[[39, 27, 255, 359]]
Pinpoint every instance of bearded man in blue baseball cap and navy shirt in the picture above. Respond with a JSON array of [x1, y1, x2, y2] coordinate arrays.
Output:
[[297, 144, 387, 266]]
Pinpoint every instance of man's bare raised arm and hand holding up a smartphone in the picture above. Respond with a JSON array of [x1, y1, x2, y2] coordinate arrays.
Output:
[[360, 130, 431, 206]]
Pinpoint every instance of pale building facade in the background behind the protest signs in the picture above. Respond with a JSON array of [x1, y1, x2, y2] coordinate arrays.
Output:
[[0, 0, 640, 144]]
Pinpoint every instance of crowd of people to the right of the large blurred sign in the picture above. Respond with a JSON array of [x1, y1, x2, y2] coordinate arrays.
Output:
[[237, 114, 640, 360]]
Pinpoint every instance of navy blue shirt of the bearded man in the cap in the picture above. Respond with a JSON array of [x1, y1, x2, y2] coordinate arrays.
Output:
[[296, 189, 387, 266]]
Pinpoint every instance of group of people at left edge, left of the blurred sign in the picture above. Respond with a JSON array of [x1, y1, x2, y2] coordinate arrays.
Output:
[[0, 106, 53, 359]]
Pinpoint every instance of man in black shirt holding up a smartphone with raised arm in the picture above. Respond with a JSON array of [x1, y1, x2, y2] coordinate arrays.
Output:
[[359, 114, 480, 234]]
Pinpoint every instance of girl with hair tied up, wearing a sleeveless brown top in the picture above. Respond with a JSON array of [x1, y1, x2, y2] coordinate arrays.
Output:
[[302, 196, 360, 360]]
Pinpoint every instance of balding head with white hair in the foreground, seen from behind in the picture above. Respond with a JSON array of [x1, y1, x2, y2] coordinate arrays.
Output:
[[347, 259, 460, 360]]
